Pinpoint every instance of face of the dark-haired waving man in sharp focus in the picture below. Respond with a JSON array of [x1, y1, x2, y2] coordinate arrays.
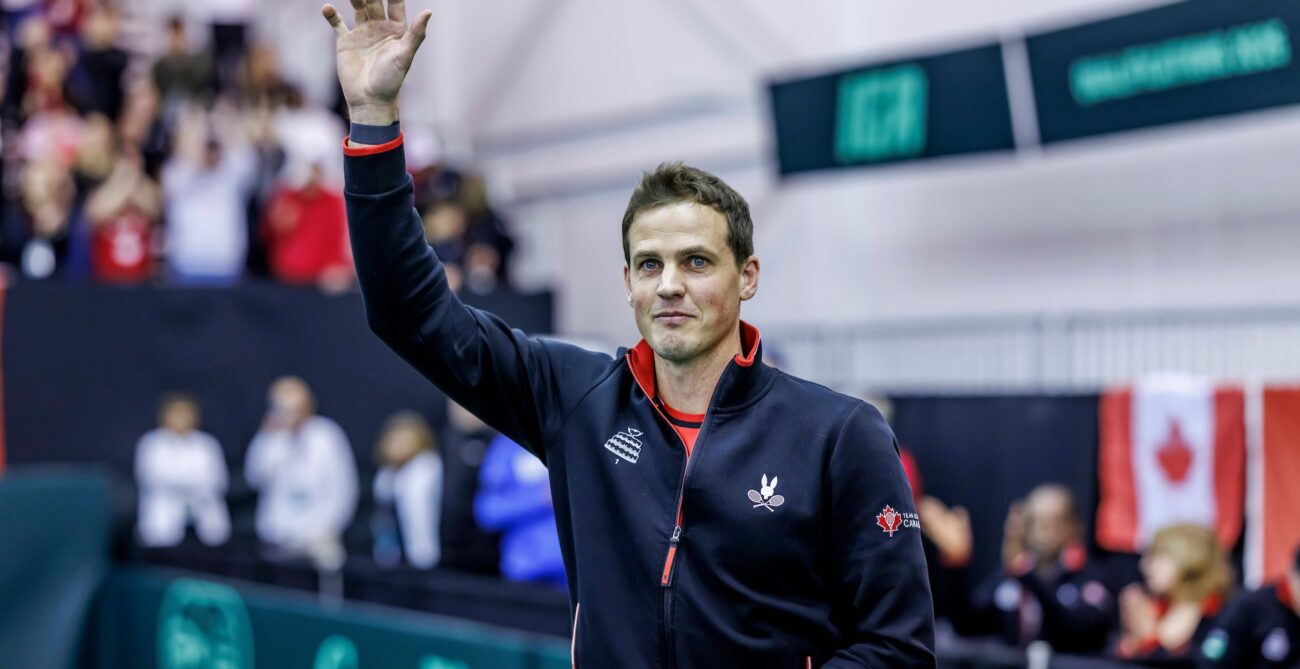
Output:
[[623, 203, 758, 364]]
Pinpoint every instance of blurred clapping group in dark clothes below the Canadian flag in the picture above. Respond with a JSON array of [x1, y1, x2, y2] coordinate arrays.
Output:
[[871, 398, 1300, 668]]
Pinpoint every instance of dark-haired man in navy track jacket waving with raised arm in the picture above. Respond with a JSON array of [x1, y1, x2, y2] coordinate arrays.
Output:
[[324, 0, 935, 669]]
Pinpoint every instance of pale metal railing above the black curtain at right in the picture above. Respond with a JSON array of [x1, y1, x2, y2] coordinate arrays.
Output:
[[764, 307, 1300, 394]]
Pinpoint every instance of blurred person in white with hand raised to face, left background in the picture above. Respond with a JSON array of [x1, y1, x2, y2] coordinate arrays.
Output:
[[244, 377, 358, 565]]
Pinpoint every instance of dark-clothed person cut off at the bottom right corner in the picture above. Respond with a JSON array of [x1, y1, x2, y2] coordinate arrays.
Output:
[[1196, 546, 1300, 669]]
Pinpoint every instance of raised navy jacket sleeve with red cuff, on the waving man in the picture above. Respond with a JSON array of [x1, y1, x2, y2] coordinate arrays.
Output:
[[343, 139, 610, 462]]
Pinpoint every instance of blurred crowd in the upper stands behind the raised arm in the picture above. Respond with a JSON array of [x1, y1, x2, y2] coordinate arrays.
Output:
[[0, 0, 514, 292]]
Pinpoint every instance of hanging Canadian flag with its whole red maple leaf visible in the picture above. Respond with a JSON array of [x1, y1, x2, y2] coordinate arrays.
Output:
[[1097, 374, 1245, 552]]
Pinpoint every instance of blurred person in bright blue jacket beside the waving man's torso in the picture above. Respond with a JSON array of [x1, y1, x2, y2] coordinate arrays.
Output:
[[475, 435, 566, 587]]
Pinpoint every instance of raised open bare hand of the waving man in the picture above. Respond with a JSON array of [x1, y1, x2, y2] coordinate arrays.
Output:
[[321, 0, 433, 126]]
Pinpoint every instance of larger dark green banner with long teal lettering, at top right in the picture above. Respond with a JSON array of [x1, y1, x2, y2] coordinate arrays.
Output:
[[1026, 0, 1300, 144]]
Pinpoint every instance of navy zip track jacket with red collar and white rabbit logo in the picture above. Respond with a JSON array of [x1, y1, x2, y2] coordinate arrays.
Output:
[[345, 138, 935, 669]]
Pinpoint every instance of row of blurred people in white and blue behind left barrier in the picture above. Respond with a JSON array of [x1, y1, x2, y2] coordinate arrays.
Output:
[[135, 377, 566, 587]]
